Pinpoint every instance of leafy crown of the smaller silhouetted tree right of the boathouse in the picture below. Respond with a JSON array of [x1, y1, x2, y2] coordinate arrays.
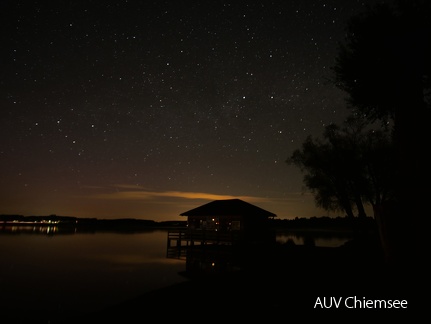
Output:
[[286, 117, 393, 217]]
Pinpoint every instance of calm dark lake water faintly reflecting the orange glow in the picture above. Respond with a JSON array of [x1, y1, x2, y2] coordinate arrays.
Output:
[[0, 228, 348, 322]]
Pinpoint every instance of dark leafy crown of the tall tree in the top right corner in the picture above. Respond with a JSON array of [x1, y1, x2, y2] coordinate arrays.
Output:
[[333, 0, 431, 123]]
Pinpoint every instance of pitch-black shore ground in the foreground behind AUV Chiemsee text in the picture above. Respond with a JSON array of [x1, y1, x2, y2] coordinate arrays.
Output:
[[5, 235, 429, 324]]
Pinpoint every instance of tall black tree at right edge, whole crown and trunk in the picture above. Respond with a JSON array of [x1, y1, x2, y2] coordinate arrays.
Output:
[[333, 0, 431, 262]]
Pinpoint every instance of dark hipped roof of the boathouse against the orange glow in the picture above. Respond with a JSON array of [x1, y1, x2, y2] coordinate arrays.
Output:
[[180, 199, 277, 217]]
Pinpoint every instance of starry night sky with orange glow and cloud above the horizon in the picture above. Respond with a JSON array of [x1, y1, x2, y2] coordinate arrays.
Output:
[[0, 0, 384, 221]]
